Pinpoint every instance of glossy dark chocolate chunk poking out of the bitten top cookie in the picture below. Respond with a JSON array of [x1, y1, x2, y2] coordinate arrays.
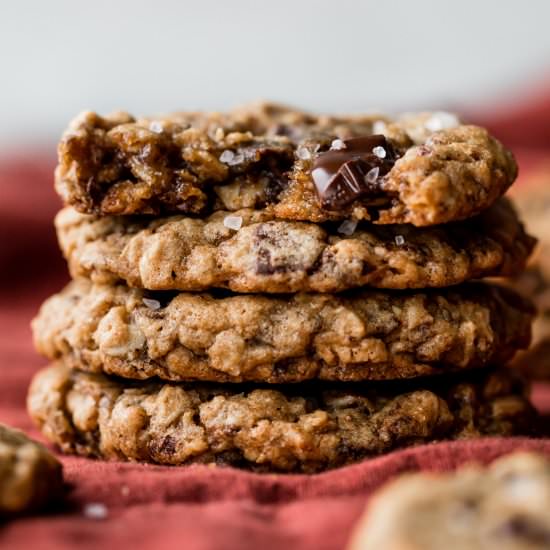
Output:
[[311, 135, 398, 209]]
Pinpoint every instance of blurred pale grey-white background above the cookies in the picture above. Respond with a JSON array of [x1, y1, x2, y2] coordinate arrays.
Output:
[[0, 0, 550, 151]]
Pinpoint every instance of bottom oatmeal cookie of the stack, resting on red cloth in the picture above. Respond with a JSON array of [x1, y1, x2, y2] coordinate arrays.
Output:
[[28, 363, 535, 472]]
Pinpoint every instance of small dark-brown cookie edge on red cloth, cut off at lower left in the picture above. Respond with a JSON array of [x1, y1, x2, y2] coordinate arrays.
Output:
[[0, 424, 63, 515]]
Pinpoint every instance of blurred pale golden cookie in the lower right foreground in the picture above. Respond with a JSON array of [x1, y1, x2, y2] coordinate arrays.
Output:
[[348, 453, 550, 550]]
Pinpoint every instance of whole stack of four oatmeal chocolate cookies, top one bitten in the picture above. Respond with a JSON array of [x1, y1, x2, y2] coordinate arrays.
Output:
[[29, 105, 534, 472]]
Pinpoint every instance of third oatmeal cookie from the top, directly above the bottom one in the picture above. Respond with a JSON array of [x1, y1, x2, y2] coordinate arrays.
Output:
[[33, 280, 533, 382]]
